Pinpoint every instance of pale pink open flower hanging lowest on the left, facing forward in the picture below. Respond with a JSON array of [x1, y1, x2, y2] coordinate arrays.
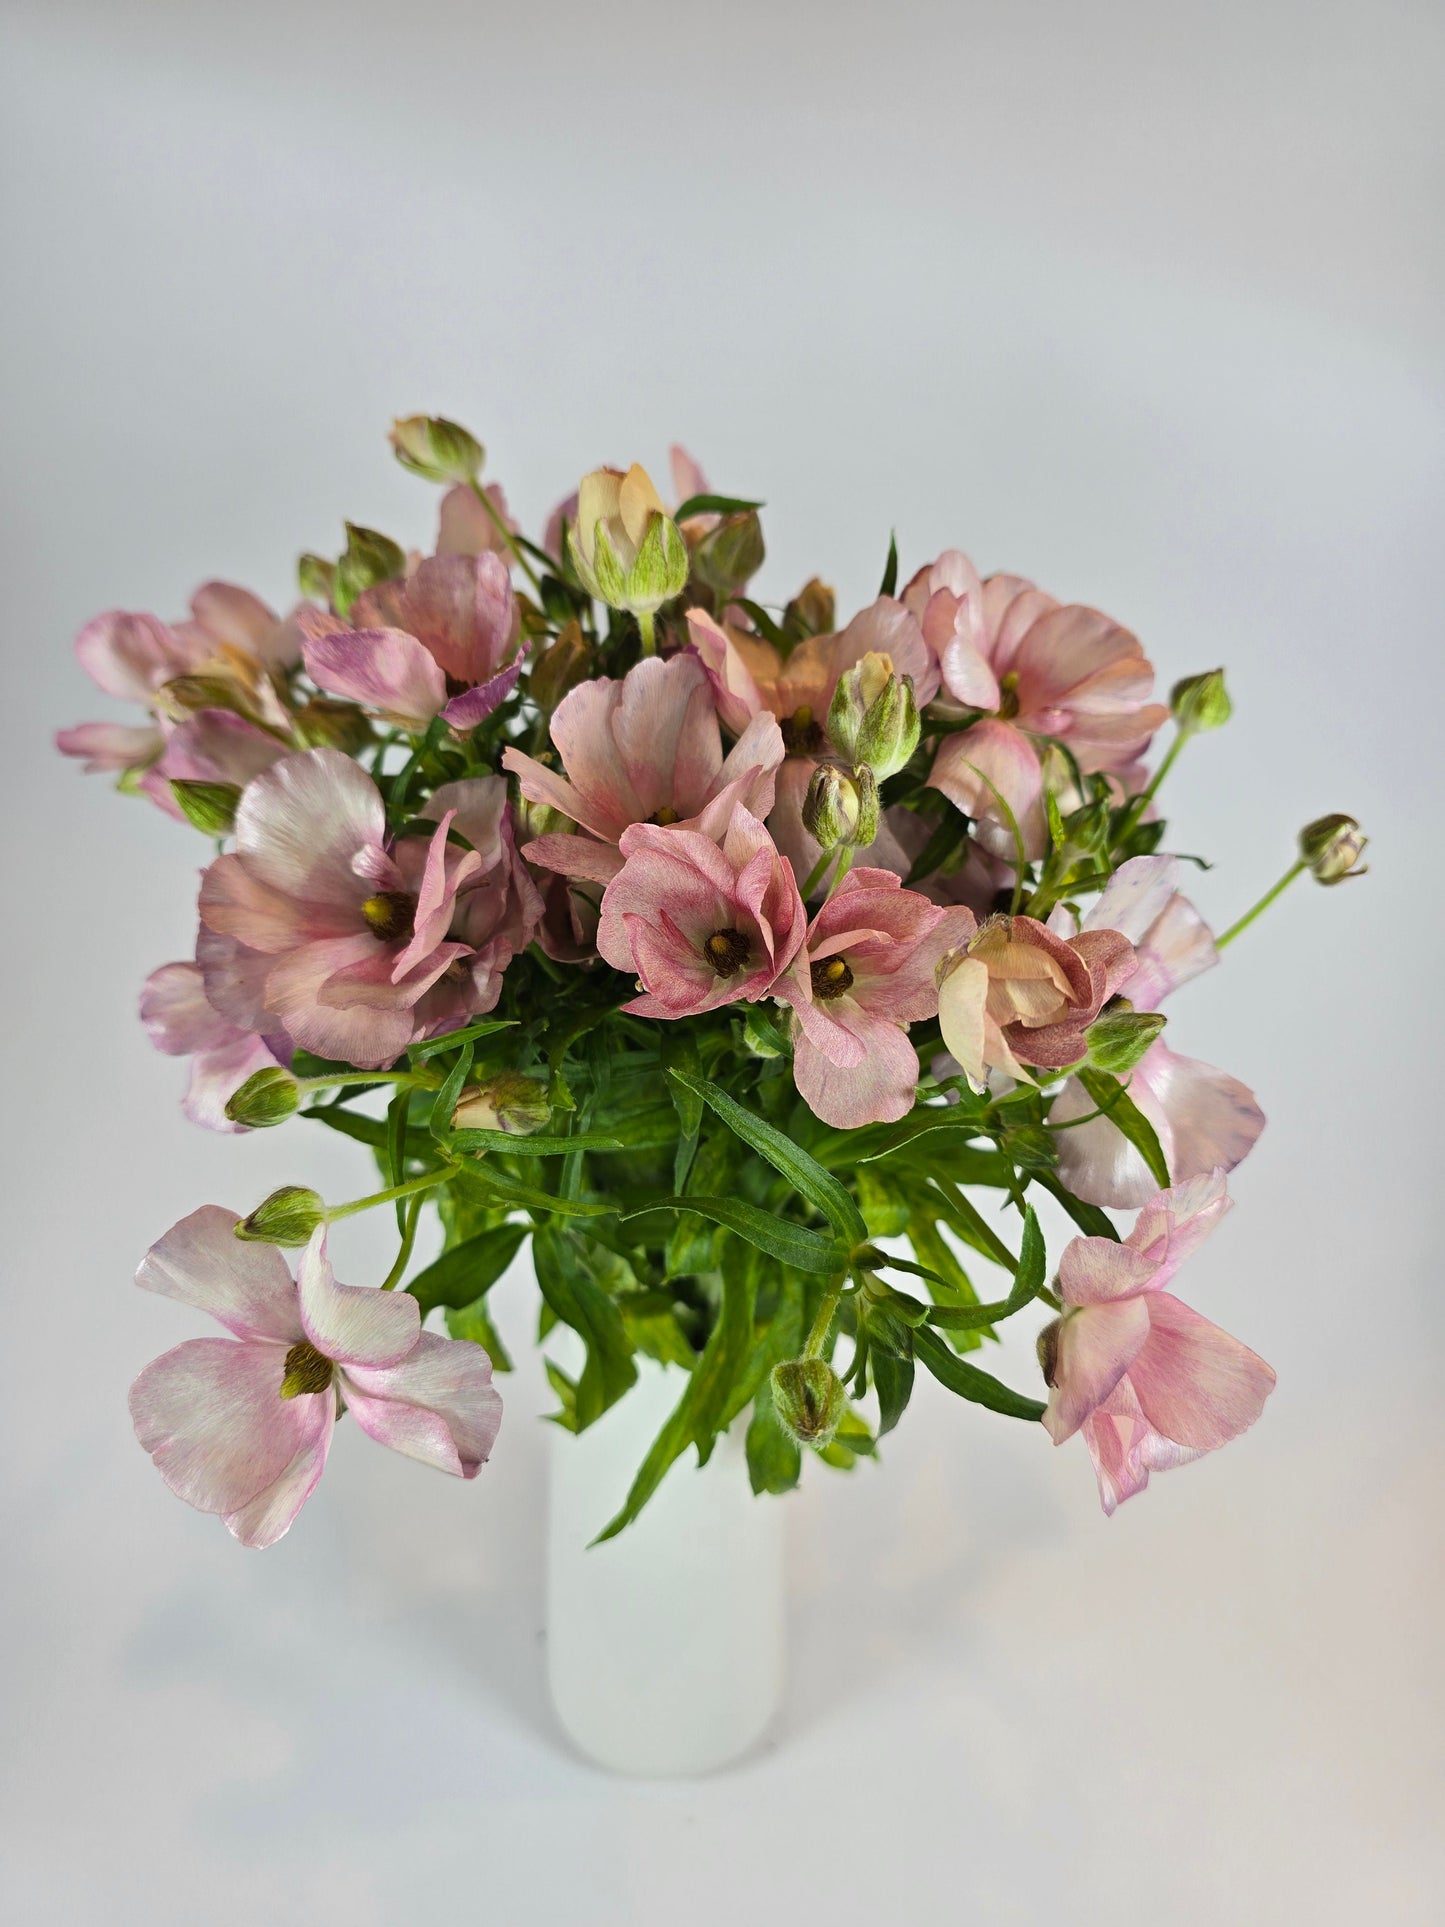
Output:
[[131, 1204, 501, 1545]]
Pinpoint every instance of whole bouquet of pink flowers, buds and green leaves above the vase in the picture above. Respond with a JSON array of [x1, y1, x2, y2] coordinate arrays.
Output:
[[58, 416, 1364, 1545]]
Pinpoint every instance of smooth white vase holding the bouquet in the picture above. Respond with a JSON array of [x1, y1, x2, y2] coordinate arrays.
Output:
[[547, 1357, 784, 1779]]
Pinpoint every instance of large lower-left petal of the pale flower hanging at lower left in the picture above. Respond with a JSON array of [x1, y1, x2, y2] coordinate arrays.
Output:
[[131, 1337, 331, 1513]]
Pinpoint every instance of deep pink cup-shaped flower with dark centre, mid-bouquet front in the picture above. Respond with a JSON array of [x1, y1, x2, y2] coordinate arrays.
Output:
[[597, 805, 807, 1017]]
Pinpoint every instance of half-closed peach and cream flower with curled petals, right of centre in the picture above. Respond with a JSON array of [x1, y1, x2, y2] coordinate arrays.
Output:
[[938, 915, 1135, 1091]]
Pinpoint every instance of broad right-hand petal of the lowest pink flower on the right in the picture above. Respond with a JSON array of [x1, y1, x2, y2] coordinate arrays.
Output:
[[1129, 1291, 1275, 1451]]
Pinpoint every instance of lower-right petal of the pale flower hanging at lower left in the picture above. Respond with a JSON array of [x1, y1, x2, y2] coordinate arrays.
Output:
[[343, 1332, 501, 1478]]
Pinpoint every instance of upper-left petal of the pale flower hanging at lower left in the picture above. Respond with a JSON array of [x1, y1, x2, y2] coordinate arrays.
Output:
[[135, 1204, 302, 1341]]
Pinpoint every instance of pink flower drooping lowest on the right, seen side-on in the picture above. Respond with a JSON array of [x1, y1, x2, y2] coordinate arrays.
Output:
[[1040, 1172, 1274, 1513]]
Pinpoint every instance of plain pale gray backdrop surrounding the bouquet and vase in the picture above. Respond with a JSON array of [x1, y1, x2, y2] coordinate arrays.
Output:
[[0, 0, 1445, 1927]]
